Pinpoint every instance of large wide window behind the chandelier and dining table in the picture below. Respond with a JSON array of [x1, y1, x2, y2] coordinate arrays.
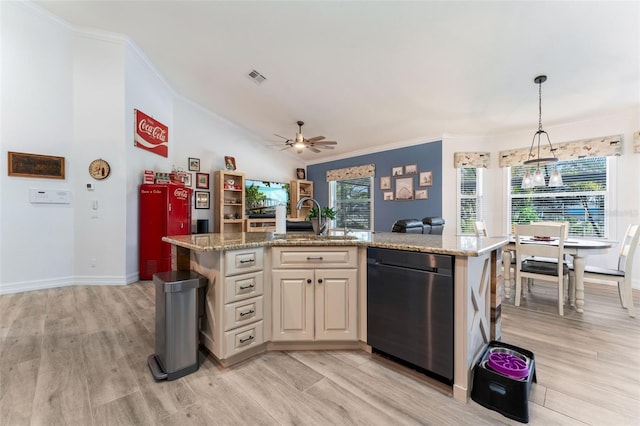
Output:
[[509, 157, 609, 238]]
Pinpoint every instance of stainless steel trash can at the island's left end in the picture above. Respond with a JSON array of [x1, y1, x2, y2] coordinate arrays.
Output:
[[147, 271, 208, 380]]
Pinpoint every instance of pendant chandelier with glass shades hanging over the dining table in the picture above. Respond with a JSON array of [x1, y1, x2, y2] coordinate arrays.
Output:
[[521, 75, 562, 189]]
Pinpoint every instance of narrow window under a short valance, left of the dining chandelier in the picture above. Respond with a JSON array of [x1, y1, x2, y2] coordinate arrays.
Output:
[[457, 168, 483, 235]]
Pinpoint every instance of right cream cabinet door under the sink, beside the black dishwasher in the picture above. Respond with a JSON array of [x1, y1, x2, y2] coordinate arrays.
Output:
[[314, 269, 358, 340]]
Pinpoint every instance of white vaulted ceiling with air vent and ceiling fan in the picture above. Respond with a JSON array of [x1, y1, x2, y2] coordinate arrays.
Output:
[[35, 0, 640, 162]]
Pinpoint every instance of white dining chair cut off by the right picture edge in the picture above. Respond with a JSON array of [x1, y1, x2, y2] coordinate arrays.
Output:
[[584, 224, 640, 317]]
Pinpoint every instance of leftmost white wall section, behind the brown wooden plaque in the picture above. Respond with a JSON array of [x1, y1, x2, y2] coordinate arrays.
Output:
[[0, 2, 75, 289]]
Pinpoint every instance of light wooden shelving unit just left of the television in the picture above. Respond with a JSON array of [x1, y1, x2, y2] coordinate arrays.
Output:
[[213, 170, 245, 233]]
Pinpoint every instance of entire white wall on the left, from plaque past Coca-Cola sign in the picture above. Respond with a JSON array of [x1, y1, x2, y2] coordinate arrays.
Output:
[[0, 2, 304, 293]]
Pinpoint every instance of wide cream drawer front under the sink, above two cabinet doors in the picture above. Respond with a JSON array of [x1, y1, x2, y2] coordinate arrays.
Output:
[[272, 247, 358, 268]]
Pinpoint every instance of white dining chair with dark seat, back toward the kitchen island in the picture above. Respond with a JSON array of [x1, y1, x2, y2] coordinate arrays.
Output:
[[515, 222, 569, 315]]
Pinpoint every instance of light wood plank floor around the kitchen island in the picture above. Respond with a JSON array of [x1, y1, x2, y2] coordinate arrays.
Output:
[[0, 281, 640, 426]]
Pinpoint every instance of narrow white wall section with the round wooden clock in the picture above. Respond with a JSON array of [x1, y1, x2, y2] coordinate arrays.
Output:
[[73, 33, 126, 284]]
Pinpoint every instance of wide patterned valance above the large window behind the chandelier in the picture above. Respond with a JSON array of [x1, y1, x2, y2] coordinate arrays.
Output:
[[498, 135, 622, 167]]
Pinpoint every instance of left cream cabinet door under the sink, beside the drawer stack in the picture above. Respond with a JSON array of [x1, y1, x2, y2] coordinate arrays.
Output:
[[271, 270, 314, 341]]
